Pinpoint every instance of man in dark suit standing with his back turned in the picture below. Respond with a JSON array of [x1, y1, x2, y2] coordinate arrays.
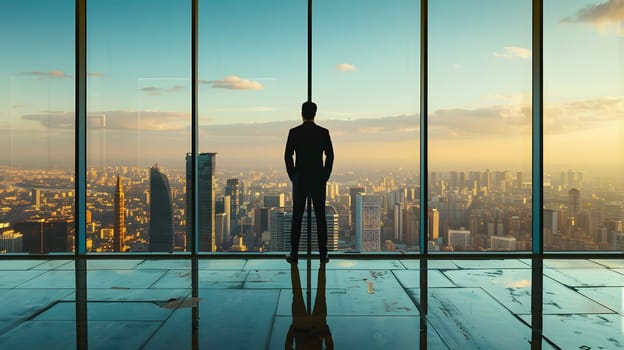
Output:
[[284, 101, 334, 263]]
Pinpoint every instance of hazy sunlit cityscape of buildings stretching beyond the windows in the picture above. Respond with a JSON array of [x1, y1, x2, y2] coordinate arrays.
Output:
[[0, 157, 624, 254]]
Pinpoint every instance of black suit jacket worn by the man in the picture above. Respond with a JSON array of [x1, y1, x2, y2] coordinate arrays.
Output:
[[284, 121, 334, 183]]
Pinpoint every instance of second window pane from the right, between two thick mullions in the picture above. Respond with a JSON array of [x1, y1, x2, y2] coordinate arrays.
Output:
[[428, 0, 532, 251]]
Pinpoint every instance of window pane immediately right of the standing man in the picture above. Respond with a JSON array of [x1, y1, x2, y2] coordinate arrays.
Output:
[[314, 0, 420, 252]]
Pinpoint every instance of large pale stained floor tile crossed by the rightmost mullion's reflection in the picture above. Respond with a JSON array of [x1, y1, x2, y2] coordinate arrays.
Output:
[[444, 269, 611, 314]]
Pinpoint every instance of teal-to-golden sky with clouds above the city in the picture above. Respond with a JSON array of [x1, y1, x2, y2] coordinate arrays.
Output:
[[0, 0, 624, 175]]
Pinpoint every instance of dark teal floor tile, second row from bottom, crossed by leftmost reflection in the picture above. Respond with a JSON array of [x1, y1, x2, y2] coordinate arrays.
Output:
[[34, 301, 173, 321]]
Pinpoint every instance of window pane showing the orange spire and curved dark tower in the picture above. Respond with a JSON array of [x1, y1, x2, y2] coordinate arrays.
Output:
[[87, 0, 191, 252]]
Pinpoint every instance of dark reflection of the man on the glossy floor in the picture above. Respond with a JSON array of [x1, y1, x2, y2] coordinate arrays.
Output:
[[285, 264, 334, 349]]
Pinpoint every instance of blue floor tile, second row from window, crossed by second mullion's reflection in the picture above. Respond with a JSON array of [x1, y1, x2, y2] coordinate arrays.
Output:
[[152, 270, 248, 289]]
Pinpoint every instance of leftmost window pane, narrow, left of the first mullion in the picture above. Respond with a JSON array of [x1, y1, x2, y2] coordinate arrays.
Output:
[[0, 0, 75, 254]]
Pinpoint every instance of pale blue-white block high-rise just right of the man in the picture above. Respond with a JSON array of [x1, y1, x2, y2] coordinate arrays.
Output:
[[355, 193, 381, 252]]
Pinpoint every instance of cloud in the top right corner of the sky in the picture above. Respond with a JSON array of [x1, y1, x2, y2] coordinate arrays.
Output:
[[560, 0, 624, 36]]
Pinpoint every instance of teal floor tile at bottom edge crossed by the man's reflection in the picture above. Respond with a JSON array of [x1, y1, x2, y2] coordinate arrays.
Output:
[[269, 316, 434, 349]]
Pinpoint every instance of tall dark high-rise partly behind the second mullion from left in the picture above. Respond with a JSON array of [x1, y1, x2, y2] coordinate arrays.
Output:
[[186, 153, 218, 252]]
